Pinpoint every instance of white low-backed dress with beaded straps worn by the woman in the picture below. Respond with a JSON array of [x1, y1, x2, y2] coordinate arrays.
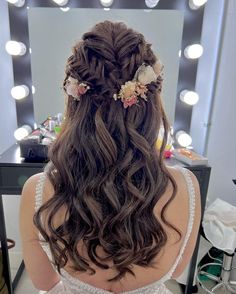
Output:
[[35, 168, 195, 294]]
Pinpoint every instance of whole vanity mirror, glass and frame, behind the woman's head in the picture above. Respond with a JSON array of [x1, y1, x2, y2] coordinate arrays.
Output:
[[6, 0, 204, 136]]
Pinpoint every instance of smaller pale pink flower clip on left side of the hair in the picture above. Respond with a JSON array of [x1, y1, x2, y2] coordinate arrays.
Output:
[[65, 77, 90, 101]]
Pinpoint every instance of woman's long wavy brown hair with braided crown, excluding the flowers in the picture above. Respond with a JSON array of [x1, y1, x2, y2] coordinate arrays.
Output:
[[34, 21, 181, 281]]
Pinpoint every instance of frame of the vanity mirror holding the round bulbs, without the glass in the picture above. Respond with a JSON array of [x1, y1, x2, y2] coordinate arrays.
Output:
[[8, 0, 204, 133]]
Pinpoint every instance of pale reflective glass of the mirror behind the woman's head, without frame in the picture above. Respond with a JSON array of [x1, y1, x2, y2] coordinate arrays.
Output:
[[28, 8, 184, 124]]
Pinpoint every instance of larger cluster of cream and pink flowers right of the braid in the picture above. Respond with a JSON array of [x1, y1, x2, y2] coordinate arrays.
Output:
[[113, 63, 163, 108]]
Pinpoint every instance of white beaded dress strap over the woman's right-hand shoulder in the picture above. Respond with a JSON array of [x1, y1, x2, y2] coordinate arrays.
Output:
[[169, 168, 196, 276]]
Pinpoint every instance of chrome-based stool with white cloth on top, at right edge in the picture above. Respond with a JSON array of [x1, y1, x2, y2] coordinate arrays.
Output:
[[197, 199, 236, 293]]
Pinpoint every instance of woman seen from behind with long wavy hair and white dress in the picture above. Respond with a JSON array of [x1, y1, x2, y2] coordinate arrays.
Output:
[[20, 21, 200, 294]]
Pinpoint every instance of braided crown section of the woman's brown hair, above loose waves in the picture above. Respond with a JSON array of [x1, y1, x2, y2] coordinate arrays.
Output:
[[66, 22, 155, 102]]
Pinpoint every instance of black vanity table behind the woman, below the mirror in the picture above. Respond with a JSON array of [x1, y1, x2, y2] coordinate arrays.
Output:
[[0, 144, 211, 294]]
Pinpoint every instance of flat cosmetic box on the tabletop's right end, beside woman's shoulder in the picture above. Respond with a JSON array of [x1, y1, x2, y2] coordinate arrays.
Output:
[[172, 148, 208, 166]]
